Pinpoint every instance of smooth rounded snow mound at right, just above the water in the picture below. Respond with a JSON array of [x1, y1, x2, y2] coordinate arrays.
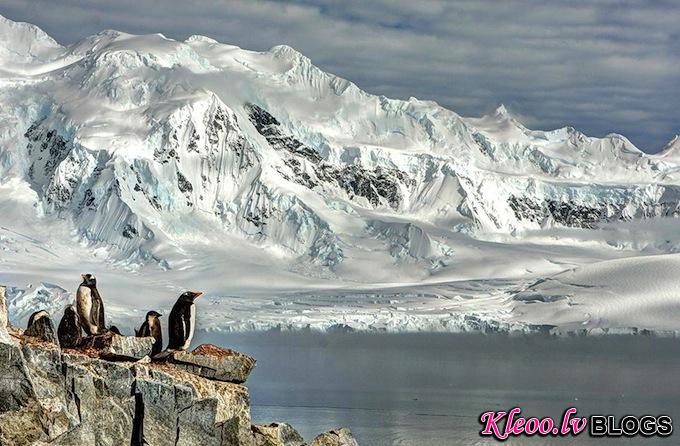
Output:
[[514, 254, 680, 331]]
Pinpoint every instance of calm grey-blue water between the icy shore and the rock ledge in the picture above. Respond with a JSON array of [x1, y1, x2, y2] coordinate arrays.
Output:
[[196, 332, 680, 446]]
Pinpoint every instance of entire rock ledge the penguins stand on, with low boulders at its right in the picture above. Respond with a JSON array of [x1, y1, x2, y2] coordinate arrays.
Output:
[[0, 286, 357, 446]]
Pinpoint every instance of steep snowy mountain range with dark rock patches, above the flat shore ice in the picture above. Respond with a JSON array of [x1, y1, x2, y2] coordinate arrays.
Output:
[[0, 17, 680, 332]]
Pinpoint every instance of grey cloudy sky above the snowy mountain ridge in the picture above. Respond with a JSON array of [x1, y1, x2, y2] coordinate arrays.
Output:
[[0, 0, 680, 152]]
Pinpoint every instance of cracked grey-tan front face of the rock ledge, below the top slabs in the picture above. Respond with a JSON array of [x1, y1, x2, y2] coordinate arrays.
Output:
[[0, 337, 254, 446]]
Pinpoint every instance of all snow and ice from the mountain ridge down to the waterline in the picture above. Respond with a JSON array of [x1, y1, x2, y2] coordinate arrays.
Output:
[[0, 17, 680, 333]]
